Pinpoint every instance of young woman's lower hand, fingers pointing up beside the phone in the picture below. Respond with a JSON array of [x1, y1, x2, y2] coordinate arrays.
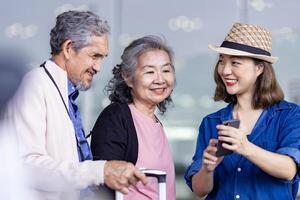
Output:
[[202, 139, 224, 172]]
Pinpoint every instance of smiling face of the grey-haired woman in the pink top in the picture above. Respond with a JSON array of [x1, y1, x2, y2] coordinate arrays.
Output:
[[127, 49, 175, 106]]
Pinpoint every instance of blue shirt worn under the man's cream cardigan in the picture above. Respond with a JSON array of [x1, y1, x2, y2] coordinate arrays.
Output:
[[68, 80, 93, 161]]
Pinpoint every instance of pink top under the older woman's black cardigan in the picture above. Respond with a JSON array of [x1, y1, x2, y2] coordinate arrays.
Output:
[[124, 104, 176, 200]]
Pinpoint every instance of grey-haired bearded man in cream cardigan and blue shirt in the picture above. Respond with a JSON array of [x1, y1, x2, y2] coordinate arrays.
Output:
[[7, 11, 147, 200]]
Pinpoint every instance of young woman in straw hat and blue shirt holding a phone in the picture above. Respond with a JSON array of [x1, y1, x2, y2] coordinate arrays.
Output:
[[185, 23, 300, 200]]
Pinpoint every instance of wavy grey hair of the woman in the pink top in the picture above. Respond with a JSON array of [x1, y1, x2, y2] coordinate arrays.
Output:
[[105, 35, 175, 114]]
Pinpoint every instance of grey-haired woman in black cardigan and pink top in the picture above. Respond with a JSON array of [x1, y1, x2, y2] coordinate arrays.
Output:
[[91, 36, 175, 200]]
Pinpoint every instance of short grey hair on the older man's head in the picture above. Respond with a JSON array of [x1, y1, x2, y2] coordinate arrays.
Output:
[[50, 11, 110, 55]]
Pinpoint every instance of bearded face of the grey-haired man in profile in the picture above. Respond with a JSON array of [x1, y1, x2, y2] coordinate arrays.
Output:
[[66, 35, 108, 91]]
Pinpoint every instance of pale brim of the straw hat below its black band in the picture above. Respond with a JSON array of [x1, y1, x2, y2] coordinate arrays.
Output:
[[208, 44, 278, 64]]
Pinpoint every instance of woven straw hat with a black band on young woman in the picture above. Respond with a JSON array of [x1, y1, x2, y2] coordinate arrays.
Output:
[[208, 23, 278, 63]]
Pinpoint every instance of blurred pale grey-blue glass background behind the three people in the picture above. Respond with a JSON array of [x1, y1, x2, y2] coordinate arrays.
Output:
[[0, 0, 300, 199]]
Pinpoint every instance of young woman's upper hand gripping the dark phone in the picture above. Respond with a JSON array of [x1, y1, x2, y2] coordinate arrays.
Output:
[[217, 125, 250, 156]]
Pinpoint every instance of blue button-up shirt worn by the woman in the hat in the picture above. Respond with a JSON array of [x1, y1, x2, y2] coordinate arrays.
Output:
[[185, 101, 300, 200]]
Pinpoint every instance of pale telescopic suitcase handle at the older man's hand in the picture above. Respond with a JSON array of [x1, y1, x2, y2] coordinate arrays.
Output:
[[116, 169, 167, 200]]
